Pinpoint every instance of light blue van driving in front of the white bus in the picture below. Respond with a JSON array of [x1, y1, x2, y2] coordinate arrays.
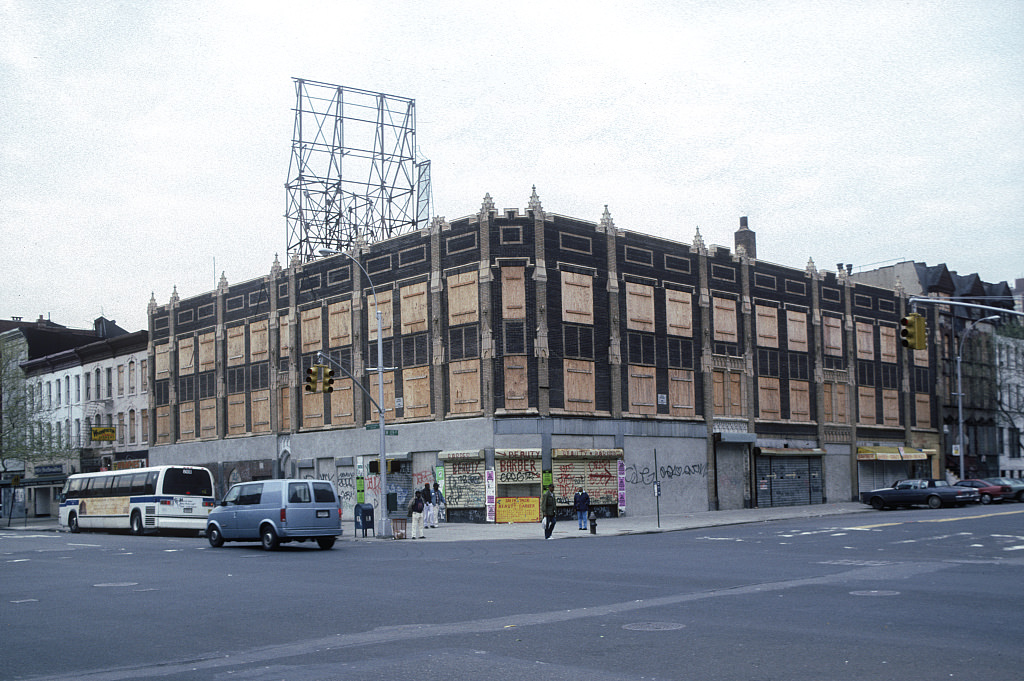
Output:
[[206, 479, 342, 551]]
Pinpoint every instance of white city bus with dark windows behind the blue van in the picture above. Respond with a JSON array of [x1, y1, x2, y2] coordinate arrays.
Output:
[[60, 466, 217, 535]]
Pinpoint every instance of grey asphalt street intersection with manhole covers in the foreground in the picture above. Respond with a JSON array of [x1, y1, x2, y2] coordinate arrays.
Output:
[[0, 504, 1024, 681]]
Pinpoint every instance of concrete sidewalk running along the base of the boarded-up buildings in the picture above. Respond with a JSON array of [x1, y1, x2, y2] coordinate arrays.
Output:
[[0, 502, 871, 542]]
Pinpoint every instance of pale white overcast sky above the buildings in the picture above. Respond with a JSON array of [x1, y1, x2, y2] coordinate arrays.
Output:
[[0, 0, 1024, 331]]
